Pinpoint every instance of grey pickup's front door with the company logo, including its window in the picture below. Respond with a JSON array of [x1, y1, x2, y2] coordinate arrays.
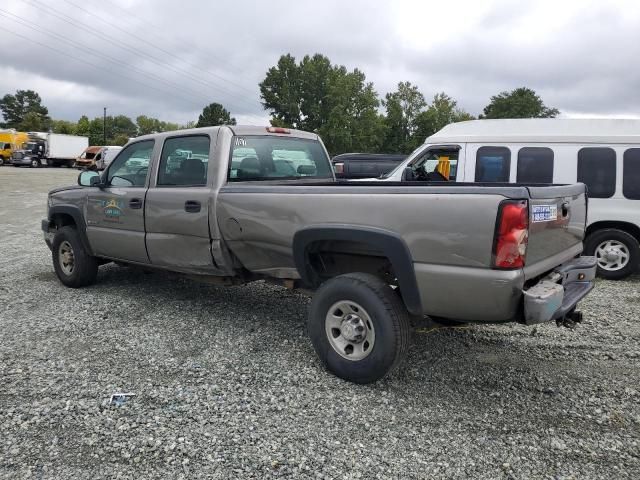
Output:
[[87, 140, 155, 263]]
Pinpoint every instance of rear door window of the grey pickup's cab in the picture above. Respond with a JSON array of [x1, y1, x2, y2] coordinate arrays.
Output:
[[158, 135, 209, 187]]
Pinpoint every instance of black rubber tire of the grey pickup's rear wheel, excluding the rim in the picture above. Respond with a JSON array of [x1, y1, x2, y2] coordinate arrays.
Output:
[[307, 273, 412, 384]]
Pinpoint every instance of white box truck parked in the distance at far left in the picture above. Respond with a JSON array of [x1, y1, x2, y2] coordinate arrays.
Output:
[[11, 132, 89, 167]]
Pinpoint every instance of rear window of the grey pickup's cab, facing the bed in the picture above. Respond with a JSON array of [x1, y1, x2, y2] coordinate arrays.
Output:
[[229, 136, 333, 182]]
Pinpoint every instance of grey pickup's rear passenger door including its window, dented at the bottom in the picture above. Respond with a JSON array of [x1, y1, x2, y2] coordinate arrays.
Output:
[[145, 134, 219, 274]]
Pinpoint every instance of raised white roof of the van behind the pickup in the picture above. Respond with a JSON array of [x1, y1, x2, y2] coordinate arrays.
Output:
[[425, 118, 640, 144]]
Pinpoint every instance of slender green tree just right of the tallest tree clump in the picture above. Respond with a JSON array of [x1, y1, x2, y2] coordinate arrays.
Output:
[[382, 82, 427, 153]]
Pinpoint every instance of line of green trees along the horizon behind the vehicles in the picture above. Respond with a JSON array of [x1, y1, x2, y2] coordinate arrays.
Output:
[[0, 54, 560, 154]]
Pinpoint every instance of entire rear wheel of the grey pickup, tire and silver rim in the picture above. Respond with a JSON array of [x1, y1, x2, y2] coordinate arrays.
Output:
[[307, 273, 411, 383]]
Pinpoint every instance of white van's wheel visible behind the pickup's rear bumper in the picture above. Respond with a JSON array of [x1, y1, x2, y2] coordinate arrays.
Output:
[[585, 228, 640, 280]]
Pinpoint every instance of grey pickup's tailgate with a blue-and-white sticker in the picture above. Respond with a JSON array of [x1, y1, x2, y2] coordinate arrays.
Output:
[[525, 183, 587, 278]]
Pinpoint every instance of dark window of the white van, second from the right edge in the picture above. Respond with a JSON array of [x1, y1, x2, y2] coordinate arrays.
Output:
[[578, 147, 616, 198]]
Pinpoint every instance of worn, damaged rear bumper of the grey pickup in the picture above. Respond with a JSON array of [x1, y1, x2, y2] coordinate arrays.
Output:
[[522, 256, 597, 325]]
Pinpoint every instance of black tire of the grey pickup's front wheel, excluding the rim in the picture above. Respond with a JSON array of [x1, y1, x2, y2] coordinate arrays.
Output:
[[51, 227, 98, 288]]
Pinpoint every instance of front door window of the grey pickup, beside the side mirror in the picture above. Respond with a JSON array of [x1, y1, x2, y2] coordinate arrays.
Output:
[[107, 140, 154, 187]]
